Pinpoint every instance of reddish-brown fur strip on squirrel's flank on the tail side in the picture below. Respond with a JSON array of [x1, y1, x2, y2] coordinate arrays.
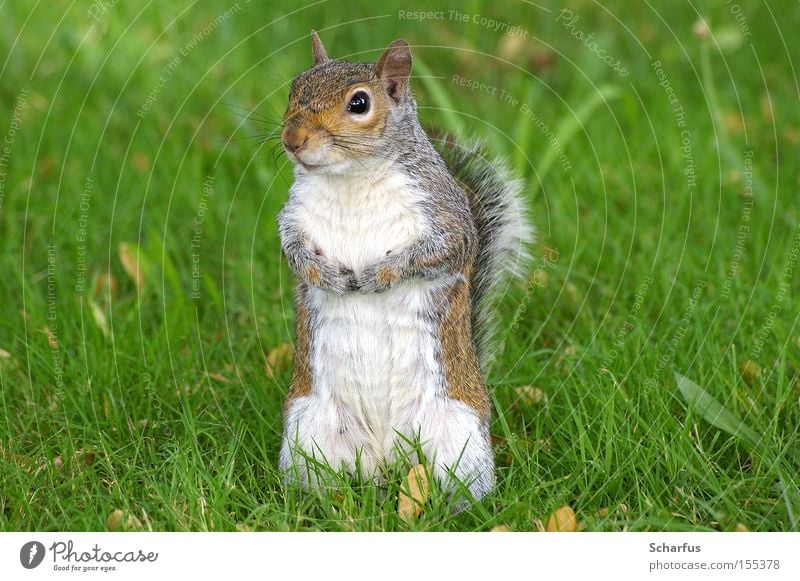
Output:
[[439, 272, 490, 418]]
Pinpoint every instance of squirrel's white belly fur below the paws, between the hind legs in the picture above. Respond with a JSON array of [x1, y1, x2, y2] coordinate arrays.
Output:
[[308, 280, 445, 457]]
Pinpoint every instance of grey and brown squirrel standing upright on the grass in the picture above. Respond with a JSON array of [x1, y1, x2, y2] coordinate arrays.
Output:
[[278, 31, 534, 500]]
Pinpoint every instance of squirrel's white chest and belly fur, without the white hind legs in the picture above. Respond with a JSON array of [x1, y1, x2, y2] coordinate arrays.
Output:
[[286, 168, 446, 461]]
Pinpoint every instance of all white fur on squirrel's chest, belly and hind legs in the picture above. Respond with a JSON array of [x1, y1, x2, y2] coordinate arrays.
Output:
[[281, 174, 493, 497]]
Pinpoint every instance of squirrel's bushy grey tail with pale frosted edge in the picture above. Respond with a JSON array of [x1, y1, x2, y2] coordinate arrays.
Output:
[[432, 133, 535, 370]]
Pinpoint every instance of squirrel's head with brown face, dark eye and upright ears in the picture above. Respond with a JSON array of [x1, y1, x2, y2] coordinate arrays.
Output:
[[281, 30, 416, 173]]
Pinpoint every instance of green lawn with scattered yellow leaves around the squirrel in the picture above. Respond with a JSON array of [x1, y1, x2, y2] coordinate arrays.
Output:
[[0, 0, 800, 531]]
